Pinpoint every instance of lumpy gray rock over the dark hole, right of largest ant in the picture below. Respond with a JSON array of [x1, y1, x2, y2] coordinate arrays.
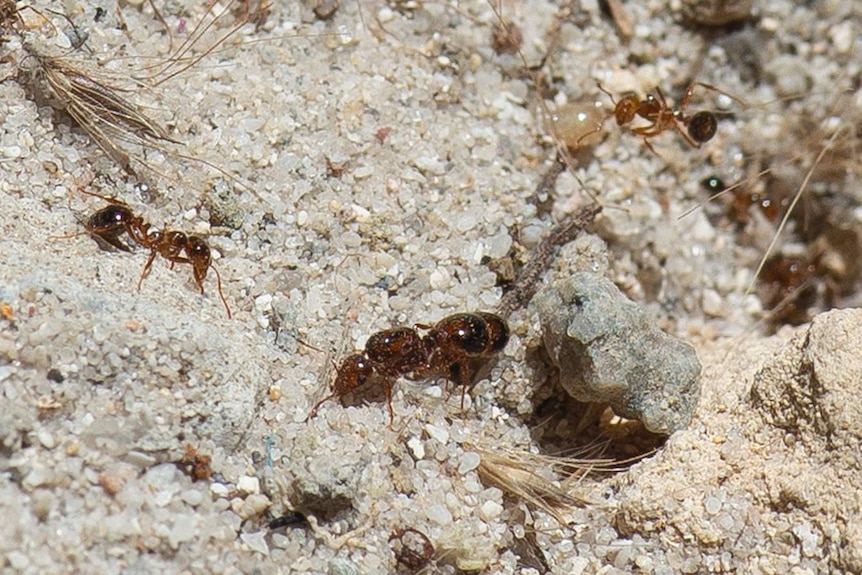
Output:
[[535, 272, 700, 434]]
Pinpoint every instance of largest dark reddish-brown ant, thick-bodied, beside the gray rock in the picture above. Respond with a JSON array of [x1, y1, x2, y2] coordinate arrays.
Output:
[[308, 312, 509, 426]]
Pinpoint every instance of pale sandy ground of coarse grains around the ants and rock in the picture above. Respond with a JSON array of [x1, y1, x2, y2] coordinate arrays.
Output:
[[0, 0, 862, 575]]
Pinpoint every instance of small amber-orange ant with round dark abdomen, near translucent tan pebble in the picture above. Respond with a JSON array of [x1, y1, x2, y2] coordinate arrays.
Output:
[[578, 82, 743, 153]]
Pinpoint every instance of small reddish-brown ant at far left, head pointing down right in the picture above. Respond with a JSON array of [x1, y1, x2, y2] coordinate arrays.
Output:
[[60, 192, 233, 319]]
